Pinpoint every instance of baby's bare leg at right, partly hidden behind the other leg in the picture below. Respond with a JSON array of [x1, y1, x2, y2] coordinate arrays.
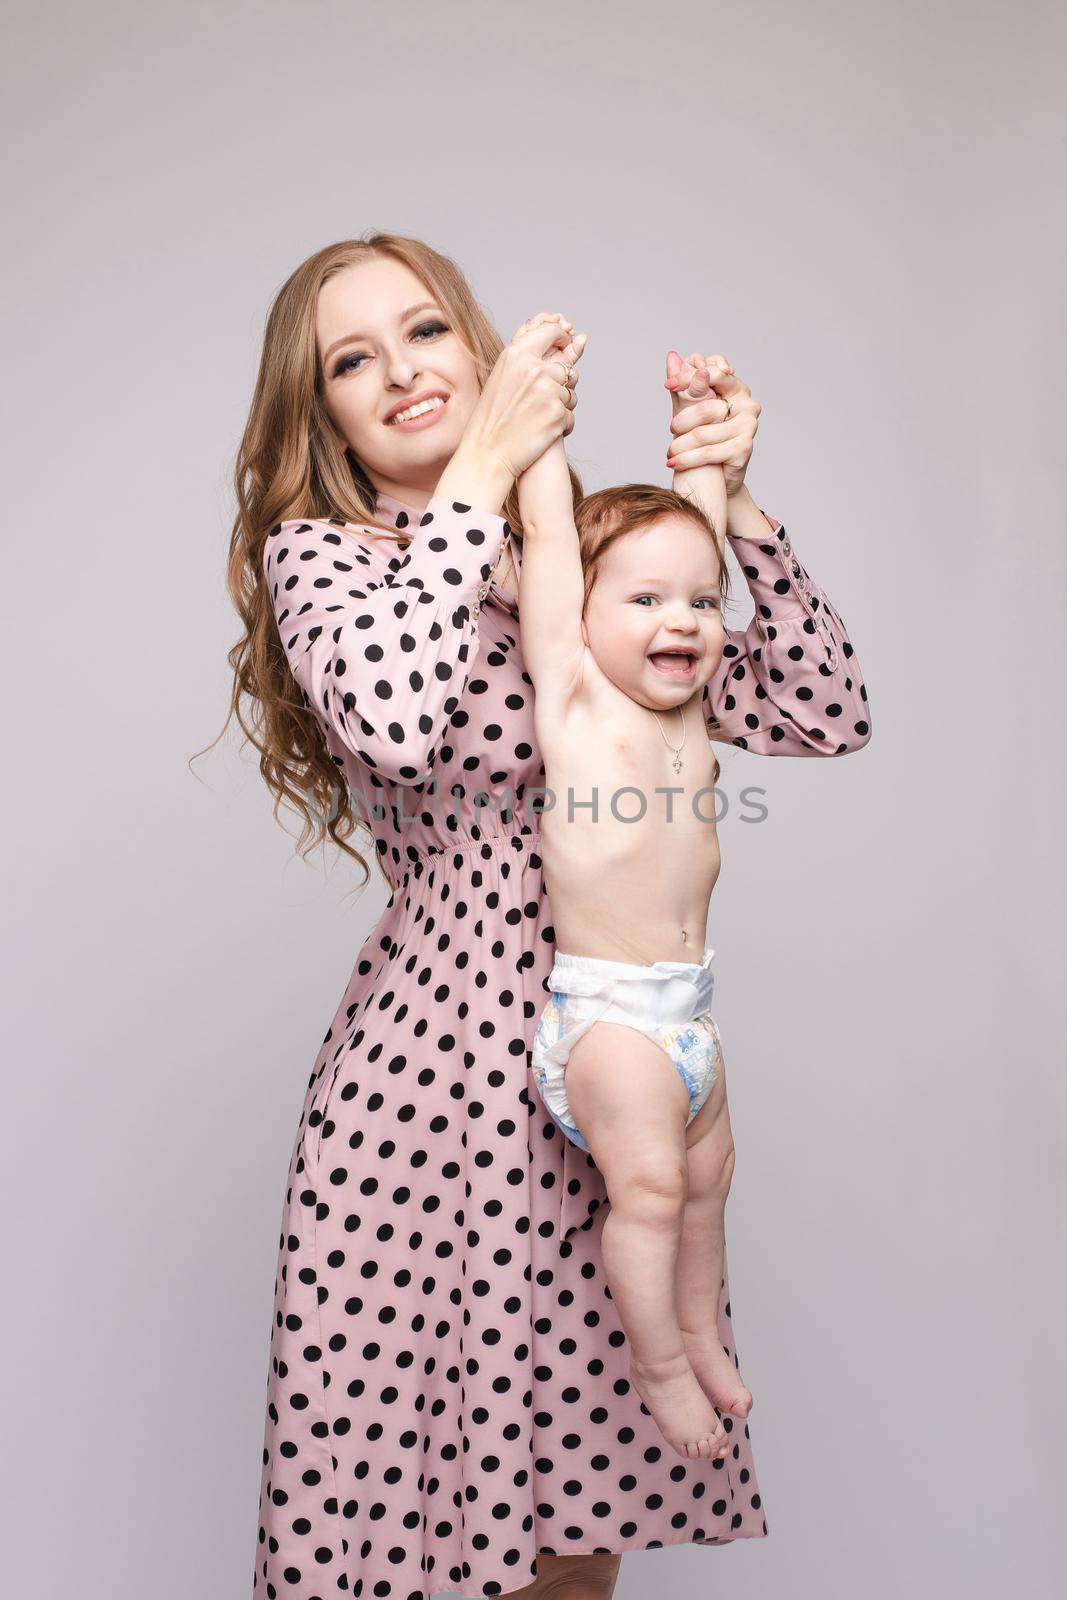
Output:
[[677, 1061, 752, 1416]]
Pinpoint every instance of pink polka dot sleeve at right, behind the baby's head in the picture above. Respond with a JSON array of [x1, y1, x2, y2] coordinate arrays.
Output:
[[704, 512, 870, 755]]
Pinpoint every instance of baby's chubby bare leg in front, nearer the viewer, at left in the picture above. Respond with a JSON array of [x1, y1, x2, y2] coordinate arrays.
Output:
[[566, 1022, 729, 1461]]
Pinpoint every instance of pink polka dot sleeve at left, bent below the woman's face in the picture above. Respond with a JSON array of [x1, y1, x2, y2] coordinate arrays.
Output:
[[262, 498, 510, 784]]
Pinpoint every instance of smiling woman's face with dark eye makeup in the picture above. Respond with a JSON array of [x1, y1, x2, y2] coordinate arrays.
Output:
[[315, 256, 480, 502]]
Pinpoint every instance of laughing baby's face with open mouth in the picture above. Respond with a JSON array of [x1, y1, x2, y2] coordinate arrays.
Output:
[[582, 514, 725, 710]]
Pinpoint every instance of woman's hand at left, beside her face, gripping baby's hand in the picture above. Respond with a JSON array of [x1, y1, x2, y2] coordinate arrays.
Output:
[[461, 312, 581, 478]]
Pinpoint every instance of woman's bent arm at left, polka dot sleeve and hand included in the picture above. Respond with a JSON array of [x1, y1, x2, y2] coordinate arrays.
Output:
[[262, 314, 588, 784]]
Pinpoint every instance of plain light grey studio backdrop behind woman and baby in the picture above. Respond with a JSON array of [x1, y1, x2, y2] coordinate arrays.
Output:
[[0, 0, 1067, 1600]]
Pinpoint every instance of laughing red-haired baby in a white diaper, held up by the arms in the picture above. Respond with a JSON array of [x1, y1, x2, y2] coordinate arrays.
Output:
[[518, 336, 752, 1459]]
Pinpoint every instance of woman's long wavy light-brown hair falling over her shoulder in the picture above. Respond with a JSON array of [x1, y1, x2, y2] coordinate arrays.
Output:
[[197, 232, 582, 888]]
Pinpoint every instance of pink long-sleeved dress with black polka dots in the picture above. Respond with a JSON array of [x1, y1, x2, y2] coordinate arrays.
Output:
[[254, 494, 869, 1600]]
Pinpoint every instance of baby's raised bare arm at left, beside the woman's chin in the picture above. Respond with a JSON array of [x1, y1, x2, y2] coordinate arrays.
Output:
[[518, 438, 585, 698]]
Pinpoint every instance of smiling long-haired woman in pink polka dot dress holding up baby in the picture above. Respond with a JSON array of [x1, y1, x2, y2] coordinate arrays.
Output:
[[230, 234, 869, 1600]]
